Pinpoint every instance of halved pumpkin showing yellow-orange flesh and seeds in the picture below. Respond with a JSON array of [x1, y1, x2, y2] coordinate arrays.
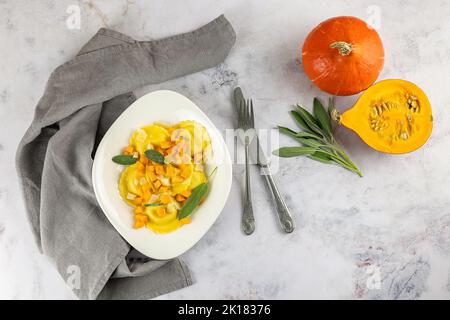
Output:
[[335, 79, 433, 154]]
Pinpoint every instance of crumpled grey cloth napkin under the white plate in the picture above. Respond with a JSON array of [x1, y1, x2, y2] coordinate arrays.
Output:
[[16, 15, 236, 299]]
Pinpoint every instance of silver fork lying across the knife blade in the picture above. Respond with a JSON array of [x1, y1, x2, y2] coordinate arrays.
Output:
[[238, 100, 255, 235]]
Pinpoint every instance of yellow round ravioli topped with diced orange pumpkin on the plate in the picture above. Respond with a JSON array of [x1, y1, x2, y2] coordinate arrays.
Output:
[[118, 120, 211, 233]]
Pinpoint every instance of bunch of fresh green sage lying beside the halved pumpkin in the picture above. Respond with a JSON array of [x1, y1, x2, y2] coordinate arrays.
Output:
[[273, 98, 363, 177]]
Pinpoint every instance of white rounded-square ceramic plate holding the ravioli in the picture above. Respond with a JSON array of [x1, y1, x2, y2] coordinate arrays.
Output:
[[92, 90, 232, 259]]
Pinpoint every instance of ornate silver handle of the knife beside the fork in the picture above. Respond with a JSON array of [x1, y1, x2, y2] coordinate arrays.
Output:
[[261, 165, 295, 233]]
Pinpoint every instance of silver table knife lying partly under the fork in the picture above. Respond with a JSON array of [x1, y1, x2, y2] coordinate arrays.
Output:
[[234, 87, 295, 233]]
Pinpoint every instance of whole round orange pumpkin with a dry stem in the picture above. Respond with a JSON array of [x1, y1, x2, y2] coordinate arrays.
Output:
[[302, 16, 384, 96]]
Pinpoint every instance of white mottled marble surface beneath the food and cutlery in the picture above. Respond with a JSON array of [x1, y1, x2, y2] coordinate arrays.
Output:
[[0, 0, 450, 299]]
